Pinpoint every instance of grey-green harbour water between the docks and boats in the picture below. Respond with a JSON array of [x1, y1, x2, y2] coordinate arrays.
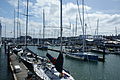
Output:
[[0, 46, 120, 80]]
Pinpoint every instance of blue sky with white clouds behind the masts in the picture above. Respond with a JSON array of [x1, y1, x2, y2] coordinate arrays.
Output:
[[0, 0, 120, 38]]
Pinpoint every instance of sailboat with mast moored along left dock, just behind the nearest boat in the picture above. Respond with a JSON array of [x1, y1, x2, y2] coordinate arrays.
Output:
[[13, 0, 41, 70]]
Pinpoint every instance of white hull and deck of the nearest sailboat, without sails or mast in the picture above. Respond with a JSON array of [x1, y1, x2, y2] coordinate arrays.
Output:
[[33, 64, 74, 80]]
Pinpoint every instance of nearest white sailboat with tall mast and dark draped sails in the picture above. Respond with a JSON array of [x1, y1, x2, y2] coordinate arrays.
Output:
[[34, 0, 74, 80]]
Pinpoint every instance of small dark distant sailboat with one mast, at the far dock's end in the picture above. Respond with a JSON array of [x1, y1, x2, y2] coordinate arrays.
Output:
[[38, 9, 48, 50]]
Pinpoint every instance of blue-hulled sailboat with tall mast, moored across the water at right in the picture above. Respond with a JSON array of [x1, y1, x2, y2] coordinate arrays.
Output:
[[66, 0, 98, 61]]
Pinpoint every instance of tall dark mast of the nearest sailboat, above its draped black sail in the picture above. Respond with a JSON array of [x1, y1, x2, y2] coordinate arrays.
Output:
[[60, 0, 63, 53]]
